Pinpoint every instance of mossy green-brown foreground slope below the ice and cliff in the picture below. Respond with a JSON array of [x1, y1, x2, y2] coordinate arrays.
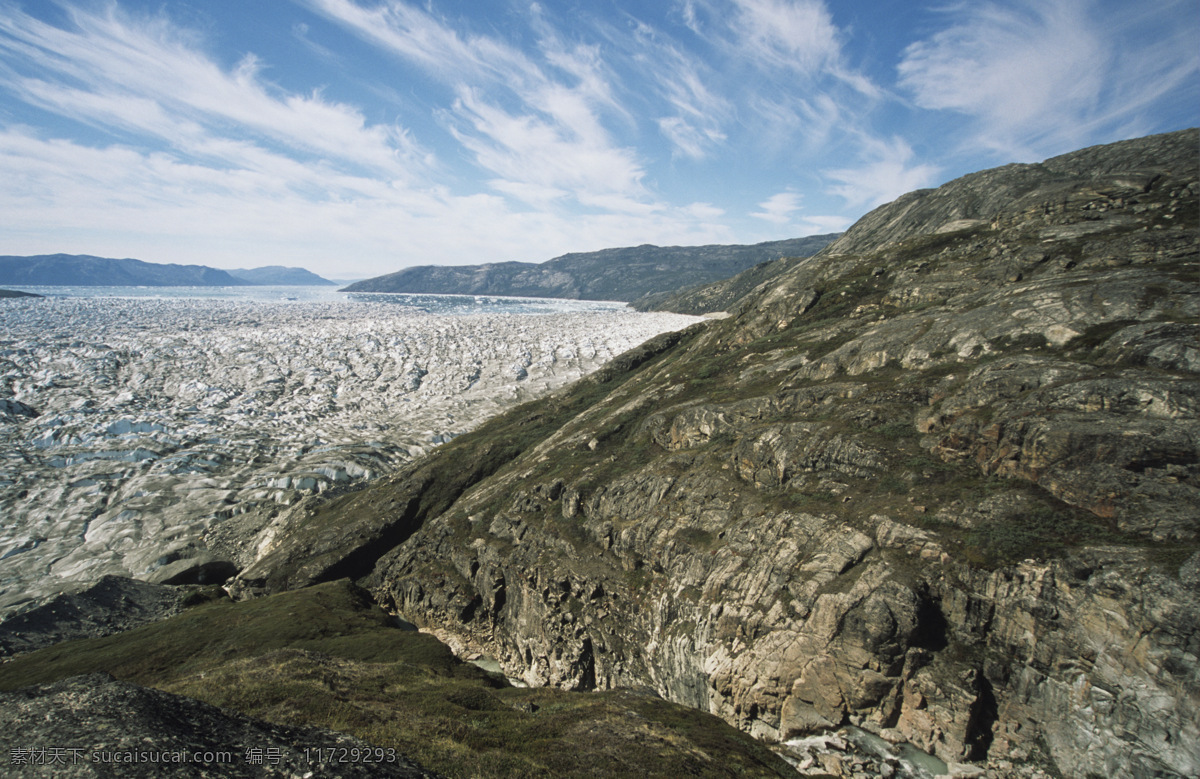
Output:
[[0, 581, 788, 777]]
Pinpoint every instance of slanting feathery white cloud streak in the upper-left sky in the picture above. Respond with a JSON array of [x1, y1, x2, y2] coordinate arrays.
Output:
[[0, 6, 428, 176]]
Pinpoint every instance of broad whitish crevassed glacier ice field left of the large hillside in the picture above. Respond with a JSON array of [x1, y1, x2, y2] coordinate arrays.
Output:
[[0, 298, 696, 616]]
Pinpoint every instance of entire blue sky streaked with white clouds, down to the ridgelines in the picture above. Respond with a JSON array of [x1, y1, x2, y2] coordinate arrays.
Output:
[[0, 0, 1200, 278]]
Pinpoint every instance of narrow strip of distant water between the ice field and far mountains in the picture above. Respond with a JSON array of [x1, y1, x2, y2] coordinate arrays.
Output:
[[5, 286, 625, 316]]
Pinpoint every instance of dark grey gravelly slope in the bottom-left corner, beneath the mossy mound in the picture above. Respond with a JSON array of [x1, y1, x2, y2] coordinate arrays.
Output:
[[0, 673, 436, 779]]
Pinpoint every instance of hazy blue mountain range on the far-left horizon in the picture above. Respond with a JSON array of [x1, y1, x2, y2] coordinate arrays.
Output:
[[0, 254, 334, 287]]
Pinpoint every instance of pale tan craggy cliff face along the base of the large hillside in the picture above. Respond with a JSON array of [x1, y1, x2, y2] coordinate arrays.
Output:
[[376, 475, 1200, 777]]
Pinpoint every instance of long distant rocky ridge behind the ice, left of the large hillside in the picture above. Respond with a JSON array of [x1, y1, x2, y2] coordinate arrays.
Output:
[[346, 234, 836, 301]]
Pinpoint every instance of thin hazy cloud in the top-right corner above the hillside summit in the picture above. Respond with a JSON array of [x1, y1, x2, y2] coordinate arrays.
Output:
[[898, 0, 1200, 160]]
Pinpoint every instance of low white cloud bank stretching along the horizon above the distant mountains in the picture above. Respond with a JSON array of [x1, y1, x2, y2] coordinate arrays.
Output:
[[0, 128, 732, 275]]
